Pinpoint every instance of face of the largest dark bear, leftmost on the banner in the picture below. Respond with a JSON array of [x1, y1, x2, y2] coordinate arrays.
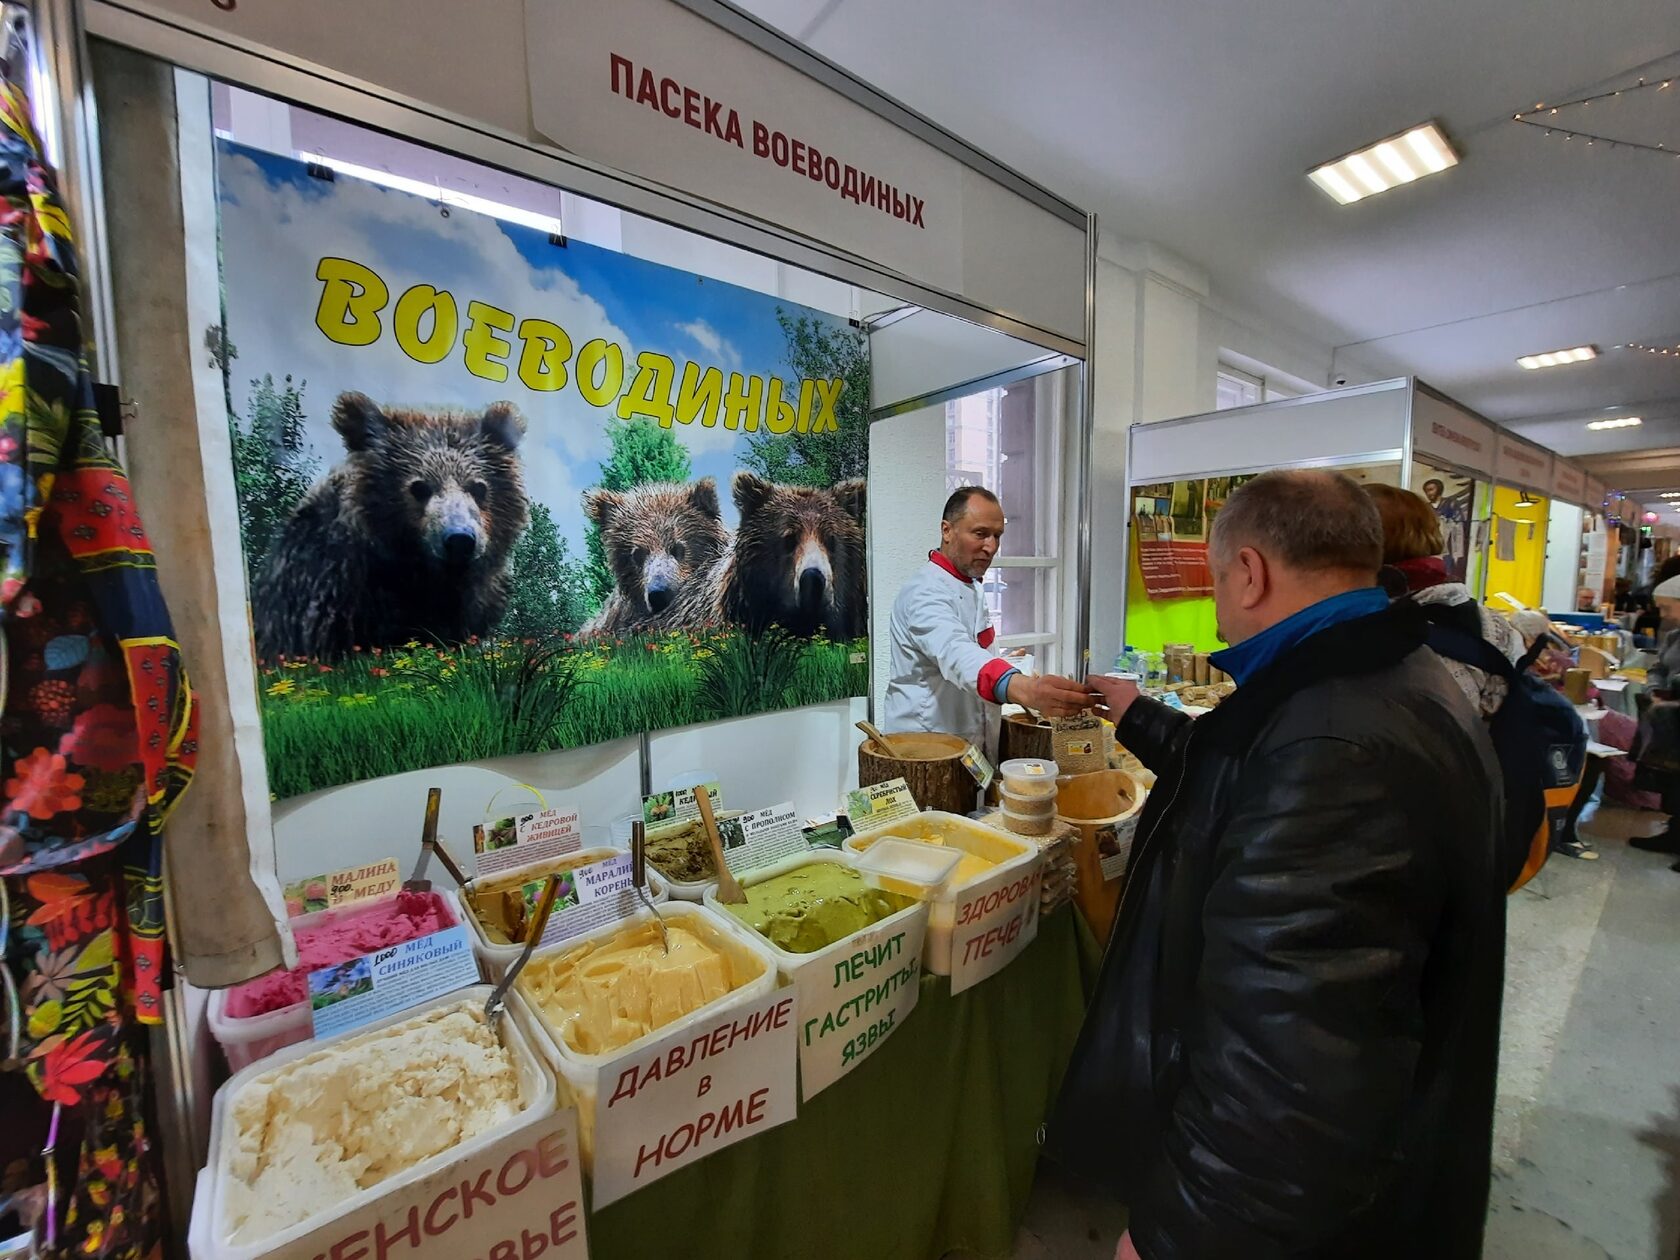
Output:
[[333, 393, 529, 578]]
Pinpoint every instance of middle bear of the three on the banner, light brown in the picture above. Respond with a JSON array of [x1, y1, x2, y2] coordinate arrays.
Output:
[[583, 477, 729, 635]]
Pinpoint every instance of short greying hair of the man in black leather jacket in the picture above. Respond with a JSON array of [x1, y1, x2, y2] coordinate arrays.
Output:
[[1208, 469, 1383, 578]]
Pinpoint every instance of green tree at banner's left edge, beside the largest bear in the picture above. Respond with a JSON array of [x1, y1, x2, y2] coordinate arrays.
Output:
[[228, 375, 319, 576]]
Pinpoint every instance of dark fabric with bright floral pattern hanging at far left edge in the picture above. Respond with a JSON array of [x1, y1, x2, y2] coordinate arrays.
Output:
[[0, 64, 187, 1260]]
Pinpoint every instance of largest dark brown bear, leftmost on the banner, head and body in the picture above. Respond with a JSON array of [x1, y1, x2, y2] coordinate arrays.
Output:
[[252, 391, 529, 660]]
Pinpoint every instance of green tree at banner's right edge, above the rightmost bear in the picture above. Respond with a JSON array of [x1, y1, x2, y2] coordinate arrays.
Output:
[[741, 309, 869, 486]]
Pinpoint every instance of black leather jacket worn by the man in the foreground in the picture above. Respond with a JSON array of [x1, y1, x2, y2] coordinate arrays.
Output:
[[1047, 603, 1505, 1260]]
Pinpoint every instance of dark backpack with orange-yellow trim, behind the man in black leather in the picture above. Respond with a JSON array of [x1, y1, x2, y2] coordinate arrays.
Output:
[[1426, 622, 1586, 892]]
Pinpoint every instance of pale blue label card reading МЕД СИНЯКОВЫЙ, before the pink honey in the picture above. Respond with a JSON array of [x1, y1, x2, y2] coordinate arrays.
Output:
[[309, 926, 479, 1037]]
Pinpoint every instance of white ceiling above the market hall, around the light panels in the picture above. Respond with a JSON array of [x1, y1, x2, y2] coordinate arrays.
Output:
[[738, 0, 1680, 470]]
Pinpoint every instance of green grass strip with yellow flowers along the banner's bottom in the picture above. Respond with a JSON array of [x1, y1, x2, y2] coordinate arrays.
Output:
[[259, 628, 869, 798]]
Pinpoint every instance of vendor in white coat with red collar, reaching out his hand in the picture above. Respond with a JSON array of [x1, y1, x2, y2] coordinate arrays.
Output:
[[880, 486, 1092, 749]]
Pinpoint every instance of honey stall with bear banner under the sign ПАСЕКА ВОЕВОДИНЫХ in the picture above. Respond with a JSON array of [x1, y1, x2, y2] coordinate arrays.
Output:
[[6, 0, 1108, 1260]]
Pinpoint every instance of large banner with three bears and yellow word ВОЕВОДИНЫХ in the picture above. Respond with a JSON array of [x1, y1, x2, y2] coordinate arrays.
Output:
[[208, 141, 869, 798]]
